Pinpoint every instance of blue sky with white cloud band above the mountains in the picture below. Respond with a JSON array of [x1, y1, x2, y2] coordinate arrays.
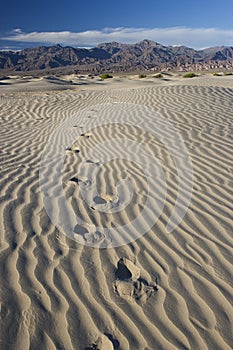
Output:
[[0, 0, 233, 50]]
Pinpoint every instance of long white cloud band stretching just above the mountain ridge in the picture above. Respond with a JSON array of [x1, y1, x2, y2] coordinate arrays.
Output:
[[1, 27, 233, 49]]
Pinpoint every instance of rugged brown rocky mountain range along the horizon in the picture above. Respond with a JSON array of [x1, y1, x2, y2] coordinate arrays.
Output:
[[0, 40, 233, 73]]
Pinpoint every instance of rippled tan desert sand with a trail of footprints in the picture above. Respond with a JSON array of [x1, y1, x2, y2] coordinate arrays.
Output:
[[0, 74, 233, 350]]
